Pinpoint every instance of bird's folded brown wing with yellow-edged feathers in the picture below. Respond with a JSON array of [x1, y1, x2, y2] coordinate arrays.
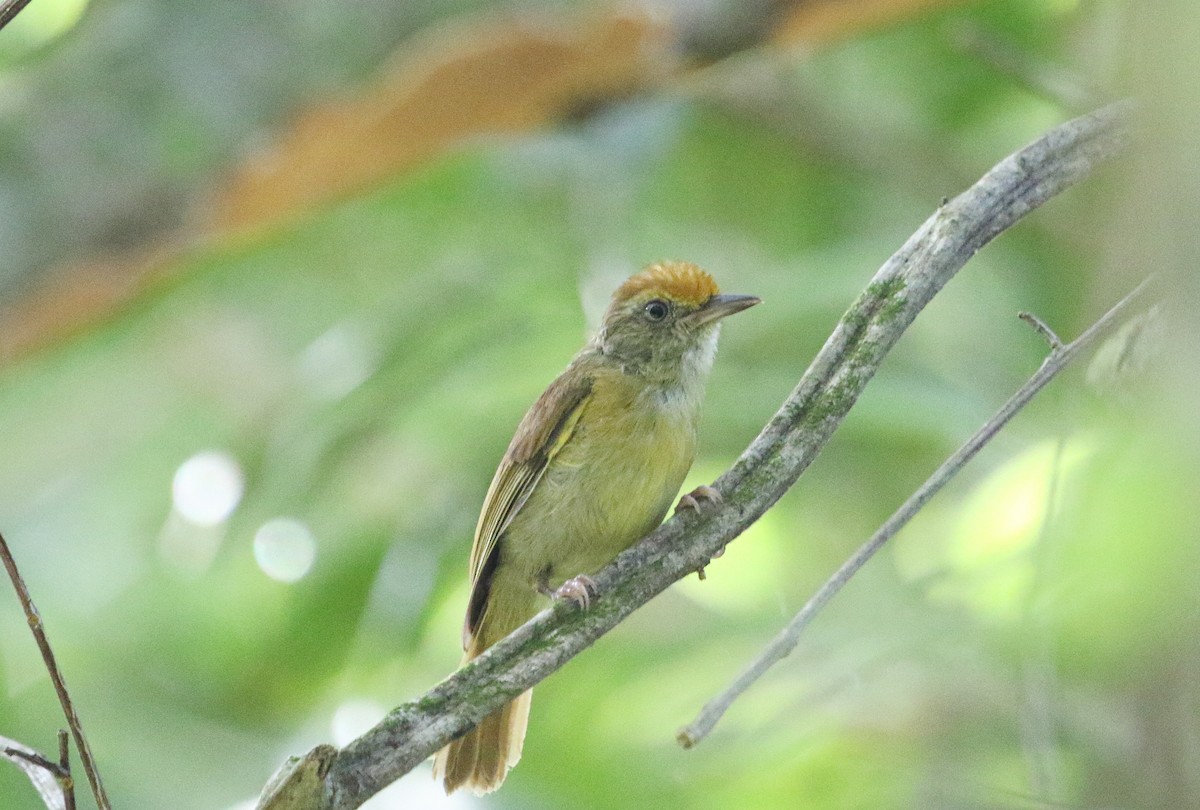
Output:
[[463, 373, 592, 648]]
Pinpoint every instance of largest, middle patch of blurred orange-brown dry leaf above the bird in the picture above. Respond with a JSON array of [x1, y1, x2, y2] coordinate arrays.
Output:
[[212, 14, 671, 230]]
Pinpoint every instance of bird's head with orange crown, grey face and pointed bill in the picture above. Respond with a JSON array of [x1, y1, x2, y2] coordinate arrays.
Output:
[[598, 262, 761, 379]]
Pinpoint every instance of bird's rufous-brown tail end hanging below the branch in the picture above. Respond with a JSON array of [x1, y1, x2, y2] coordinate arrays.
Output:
[[433, 690, 533, 794]]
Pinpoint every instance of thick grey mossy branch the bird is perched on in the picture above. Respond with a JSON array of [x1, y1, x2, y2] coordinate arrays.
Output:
[[270, 103, 1129, 810]]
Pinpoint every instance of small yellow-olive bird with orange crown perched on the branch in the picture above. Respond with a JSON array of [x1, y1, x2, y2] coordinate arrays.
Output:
[[433, 262, 760, 793]]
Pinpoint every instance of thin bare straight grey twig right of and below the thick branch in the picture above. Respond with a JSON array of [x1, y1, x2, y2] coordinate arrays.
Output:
[[677, 280, 1150, 748]]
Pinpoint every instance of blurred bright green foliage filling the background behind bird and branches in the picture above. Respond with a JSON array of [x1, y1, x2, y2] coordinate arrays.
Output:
[[0, 0, 1200, 810]]
